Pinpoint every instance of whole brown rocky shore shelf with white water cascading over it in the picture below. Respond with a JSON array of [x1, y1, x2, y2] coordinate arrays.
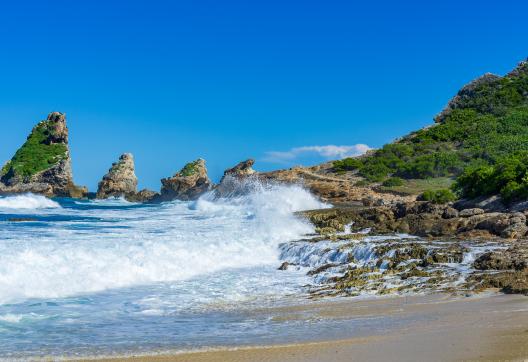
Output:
[[302, 202, 528, 295]]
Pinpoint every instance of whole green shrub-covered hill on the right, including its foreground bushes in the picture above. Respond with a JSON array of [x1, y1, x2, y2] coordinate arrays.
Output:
[[334, 61, 528, 200]]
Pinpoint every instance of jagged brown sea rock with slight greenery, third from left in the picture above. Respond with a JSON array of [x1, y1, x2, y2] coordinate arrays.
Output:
[[158, 158, 213, 201]]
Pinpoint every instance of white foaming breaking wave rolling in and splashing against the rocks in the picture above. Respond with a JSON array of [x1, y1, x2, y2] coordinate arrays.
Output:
[[0, 180, 325, 303]]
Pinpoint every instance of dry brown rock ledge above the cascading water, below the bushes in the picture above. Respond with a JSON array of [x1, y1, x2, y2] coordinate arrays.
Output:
[[304, 201, 528, 239]]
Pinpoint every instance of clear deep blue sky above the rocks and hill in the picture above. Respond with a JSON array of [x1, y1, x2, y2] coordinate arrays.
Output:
[[0, 0, 528, 189]]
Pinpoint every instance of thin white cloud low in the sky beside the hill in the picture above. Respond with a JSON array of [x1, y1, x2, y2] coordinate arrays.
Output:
[[262, 143, 371, 163]]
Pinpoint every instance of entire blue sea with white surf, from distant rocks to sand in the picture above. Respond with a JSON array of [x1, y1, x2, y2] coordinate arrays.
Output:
[[0, 185, 338, 360]]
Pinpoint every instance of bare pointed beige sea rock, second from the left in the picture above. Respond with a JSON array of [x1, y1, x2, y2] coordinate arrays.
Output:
[[96, 153, 138, 199]]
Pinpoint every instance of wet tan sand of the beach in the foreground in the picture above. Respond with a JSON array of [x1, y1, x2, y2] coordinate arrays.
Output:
[[82, 295, 528, 362]]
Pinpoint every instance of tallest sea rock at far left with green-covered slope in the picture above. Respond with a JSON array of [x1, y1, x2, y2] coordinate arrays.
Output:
[[0, 112, 87, 198]]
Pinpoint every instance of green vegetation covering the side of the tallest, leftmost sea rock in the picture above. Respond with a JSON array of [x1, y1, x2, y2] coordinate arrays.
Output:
[[0, 121, 68, 180]]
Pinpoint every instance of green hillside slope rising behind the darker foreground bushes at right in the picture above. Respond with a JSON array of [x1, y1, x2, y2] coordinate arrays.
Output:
[[334, 62, 528, 198]]
